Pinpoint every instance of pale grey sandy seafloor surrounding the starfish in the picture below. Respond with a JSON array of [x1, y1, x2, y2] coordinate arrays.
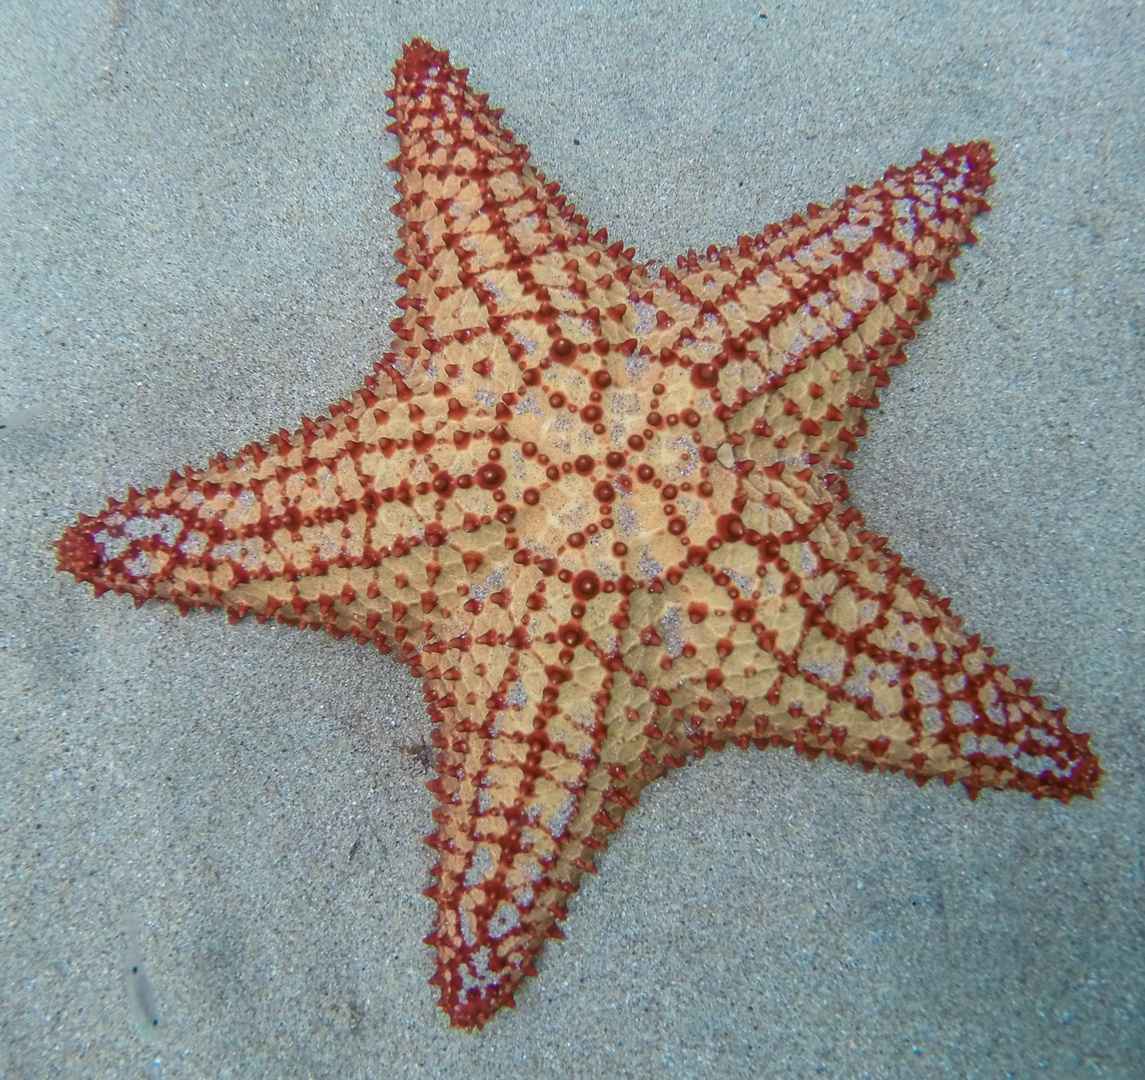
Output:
[[0, 0, 1145, 1080]]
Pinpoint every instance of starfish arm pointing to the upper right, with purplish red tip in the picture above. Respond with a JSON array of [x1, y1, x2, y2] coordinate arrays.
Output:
[[642, 142, 994, 470]]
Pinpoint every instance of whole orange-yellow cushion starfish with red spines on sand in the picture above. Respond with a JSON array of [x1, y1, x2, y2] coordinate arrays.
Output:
[[56, 39, 1100, 1027]]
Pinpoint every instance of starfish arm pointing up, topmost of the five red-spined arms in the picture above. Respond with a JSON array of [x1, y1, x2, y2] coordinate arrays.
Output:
[[382, 33, 646, 430]]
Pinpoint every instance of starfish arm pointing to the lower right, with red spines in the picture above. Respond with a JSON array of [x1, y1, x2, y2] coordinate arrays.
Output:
[[614, 467, 1101, 802]]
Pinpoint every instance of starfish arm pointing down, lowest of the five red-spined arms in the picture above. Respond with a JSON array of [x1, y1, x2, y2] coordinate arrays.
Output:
[[426, 604, 613, 1027]]
